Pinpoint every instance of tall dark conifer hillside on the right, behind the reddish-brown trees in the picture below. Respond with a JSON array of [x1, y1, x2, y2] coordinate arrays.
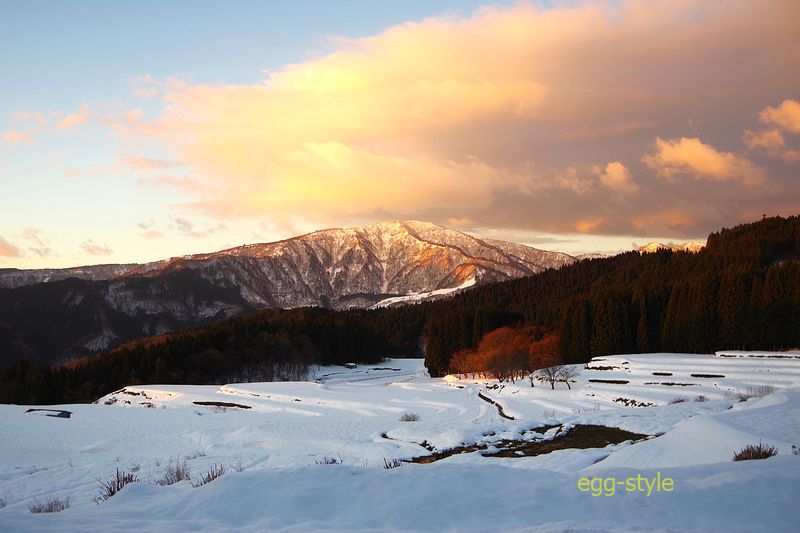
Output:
[[427, 217, 800, 373]]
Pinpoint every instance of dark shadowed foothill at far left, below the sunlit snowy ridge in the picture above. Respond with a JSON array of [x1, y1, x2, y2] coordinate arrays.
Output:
[[0, 270, 253, 369]]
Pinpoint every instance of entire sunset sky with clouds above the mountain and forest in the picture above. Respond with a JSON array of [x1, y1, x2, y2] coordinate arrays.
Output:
[[0, 0, 800, 268]]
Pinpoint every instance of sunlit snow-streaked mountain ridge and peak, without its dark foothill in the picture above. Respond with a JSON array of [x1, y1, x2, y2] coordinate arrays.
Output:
[[0, 221, 574, 308]]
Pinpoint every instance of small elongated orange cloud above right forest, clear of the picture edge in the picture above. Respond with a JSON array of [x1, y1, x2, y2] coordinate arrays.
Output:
[[642, 137, 766, 186]]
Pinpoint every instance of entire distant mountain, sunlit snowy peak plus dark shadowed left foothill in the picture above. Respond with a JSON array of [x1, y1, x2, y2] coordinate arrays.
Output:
[[0, 218, 574, 364]]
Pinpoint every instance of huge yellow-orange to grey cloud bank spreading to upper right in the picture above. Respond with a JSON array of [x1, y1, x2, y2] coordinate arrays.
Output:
[[109, 0, 800, 237]]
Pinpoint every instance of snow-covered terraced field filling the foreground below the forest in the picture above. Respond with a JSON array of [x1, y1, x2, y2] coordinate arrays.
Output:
[[0, 352, 800, 531]]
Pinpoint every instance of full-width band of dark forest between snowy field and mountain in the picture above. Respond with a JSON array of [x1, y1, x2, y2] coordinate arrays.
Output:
[[0, 217, 800, 403]]
